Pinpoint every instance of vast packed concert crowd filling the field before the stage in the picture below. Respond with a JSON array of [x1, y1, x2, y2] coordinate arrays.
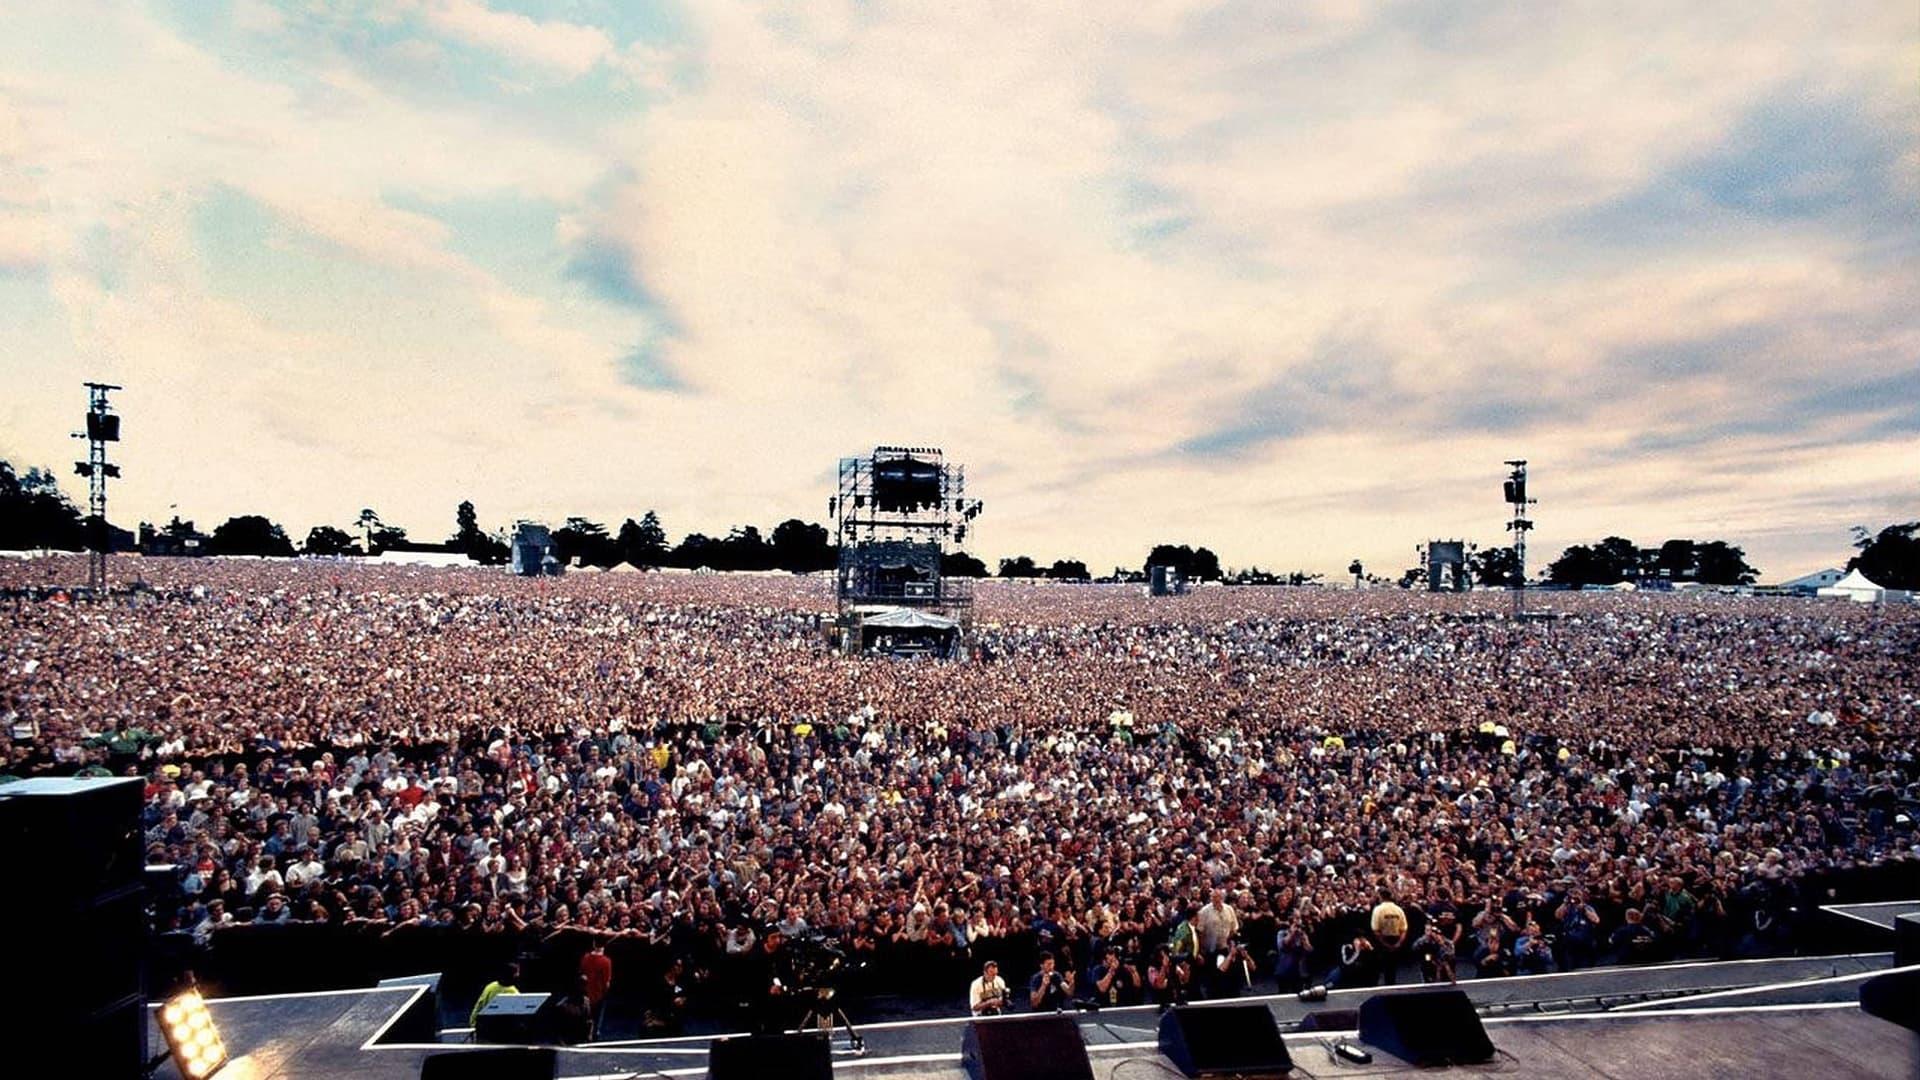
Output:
[[0, 559, 1920, 1026]]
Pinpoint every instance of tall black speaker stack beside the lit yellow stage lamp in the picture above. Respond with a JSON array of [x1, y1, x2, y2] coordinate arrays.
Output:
[[0, 776, 148, 1076]]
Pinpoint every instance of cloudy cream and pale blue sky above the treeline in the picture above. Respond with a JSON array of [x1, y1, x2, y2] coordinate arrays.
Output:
[[0, 0, 1920, 580]]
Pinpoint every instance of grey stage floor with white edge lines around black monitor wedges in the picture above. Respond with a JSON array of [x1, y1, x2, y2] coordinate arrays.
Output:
[[154, 953, 1920, 1080]]
